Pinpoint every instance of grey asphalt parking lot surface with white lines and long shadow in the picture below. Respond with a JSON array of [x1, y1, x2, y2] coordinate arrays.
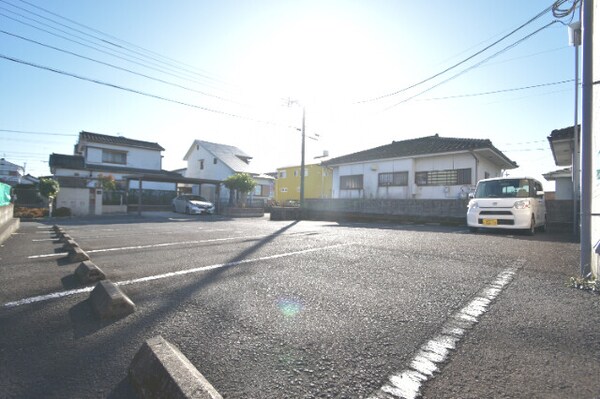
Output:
[[0, 213, 600, 398]]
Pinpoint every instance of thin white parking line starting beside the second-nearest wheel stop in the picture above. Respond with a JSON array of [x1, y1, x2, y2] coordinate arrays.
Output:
[[2, 243, 351, 308]]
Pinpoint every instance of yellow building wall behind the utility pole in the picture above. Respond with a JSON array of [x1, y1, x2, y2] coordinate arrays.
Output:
[[275, 165, 333, 204]]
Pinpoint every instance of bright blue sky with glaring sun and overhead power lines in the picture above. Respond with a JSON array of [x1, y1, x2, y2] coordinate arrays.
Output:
[[0, 0, 581, 191]]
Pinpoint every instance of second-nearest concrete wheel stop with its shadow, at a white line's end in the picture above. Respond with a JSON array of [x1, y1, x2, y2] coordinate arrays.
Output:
[[90, 280, 136, 319]]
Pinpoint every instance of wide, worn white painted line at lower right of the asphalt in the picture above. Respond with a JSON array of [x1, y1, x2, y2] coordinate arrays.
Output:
[[369, 261, 522, 399]]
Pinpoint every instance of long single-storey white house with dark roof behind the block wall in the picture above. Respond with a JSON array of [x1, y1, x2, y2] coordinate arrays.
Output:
[[323, 134, 517, 199]]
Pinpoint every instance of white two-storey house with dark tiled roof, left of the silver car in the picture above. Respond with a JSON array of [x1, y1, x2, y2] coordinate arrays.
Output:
[[50, 131, 179, 215]]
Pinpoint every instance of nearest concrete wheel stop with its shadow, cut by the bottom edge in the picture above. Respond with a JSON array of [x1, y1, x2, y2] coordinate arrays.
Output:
[[128, 335, 223, 399]]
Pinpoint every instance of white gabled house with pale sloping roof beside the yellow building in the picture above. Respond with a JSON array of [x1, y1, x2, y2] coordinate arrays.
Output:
[[183, 140, 275, 203]]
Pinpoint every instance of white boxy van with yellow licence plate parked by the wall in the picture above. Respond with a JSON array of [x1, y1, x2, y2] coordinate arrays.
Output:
[[467, 177, 546, 235]]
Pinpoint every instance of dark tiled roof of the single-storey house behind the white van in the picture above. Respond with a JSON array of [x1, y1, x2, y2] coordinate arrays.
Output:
[[323, 134, 516, 167]]
